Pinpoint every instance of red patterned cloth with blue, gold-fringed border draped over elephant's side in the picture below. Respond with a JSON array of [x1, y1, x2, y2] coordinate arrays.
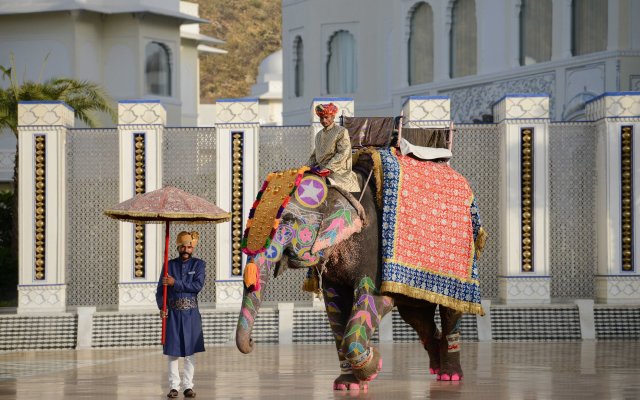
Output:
[[379, 149, 484, 315]]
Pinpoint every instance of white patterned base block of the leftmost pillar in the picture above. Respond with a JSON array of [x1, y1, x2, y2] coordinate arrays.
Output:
[[18, 284, 67, 314]]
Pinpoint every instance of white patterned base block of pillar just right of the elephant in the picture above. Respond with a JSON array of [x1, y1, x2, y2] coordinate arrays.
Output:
[[498, 276, 551, 304]]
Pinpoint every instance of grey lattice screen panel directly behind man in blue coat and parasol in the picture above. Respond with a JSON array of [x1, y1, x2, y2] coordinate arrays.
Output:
[[162, 127, 218, 305]]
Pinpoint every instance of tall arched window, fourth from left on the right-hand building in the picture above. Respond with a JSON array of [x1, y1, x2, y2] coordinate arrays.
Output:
[[449, 0, 478, 78]]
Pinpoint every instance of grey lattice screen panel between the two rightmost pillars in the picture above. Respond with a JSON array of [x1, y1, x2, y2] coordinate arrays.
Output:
[[549, 122, 596, 299]]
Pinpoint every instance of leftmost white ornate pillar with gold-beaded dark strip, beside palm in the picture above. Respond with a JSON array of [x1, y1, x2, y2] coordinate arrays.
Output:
[[18, 101, 74, 313]]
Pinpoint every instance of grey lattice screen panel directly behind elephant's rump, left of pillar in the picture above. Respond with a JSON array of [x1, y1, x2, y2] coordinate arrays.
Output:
[[451, 124, 500, 299]]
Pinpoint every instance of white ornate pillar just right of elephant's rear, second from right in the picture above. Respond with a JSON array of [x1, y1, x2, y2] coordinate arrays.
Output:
[[493, 94, 551, 303]]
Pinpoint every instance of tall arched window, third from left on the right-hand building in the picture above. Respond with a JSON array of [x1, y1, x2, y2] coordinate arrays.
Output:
[[409, 3, 433, 85]]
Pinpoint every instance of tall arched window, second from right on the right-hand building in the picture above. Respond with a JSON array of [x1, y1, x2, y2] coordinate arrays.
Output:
[[520, 0, 552, 65]]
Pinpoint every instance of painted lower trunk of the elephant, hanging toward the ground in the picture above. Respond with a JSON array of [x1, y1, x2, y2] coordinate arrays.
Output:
[[236, 259, 270, 354]]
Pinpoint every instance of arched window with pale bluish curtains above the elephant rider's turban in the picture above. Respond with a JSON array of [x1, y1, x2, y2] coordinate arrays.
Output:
[[327, 31, 357, 94]]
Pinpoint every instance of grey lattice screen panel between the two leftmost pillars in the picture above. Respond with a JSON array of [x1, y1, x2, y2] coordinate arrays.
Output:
[[66, 129, 119, 307]]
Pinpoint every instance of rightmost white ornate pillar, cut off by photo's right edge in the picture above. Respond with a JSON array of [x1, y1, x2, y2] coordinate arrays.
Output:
[[586, 92, 640, 304]]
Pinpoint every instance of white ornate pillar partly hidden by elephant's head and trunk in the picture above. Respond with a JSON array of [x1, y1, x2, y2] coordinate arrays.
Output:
[[216, 99, 262, 307]]
